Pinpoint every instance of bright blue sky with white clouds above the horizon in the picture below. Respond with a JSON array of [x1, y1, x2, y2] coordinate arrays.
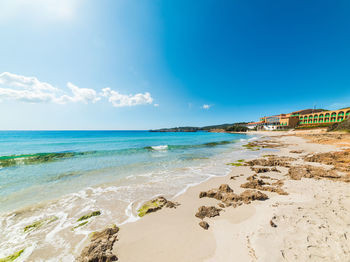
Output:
[[0, 0, 350, 130]]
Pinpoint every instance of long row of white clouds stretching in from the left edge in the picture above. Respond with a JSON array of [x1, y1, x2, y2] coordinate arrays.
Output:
[[0, 72, 154, 107]]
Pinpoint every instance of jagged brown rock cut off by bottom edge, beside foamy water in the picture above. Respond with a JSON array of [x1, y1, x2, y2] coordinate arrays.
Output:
[[77, 226, 119, 262]]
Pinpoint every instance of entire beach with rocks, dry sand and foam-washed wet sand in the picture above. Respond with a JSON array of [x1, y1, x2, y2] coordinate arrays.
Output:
[[0, 131, 350, 262]]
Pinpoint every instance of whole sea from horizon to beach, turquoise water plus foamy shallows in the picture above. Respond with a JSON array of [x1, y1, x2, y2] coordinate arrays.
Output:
[[0, 131, 259, 261]]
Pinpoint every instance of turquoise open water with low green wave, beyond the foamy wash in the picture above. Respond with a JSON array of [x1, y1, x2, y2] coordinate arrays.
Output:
[[0, 131, 247, 212]]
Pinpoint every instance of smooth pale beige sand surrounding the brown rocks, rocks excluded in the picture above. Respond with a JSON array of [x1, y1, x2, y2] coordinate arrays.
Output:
[[81, 132, 350, 261]]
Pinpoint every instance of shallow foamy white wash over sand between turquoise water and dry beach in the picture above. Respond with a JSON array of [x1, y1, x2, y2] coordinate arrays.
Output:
[[0, 132, 255, 261]]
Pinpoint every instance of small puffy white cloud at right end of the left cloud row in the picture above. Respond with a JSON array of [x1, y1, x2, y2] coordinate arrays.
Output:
[[101, 87, 153, 107]]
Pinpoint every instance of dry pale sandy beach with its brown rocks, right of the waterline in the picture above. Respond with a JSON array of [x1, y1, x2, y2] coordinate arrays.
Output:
[[78, 131, 350, 262]]
